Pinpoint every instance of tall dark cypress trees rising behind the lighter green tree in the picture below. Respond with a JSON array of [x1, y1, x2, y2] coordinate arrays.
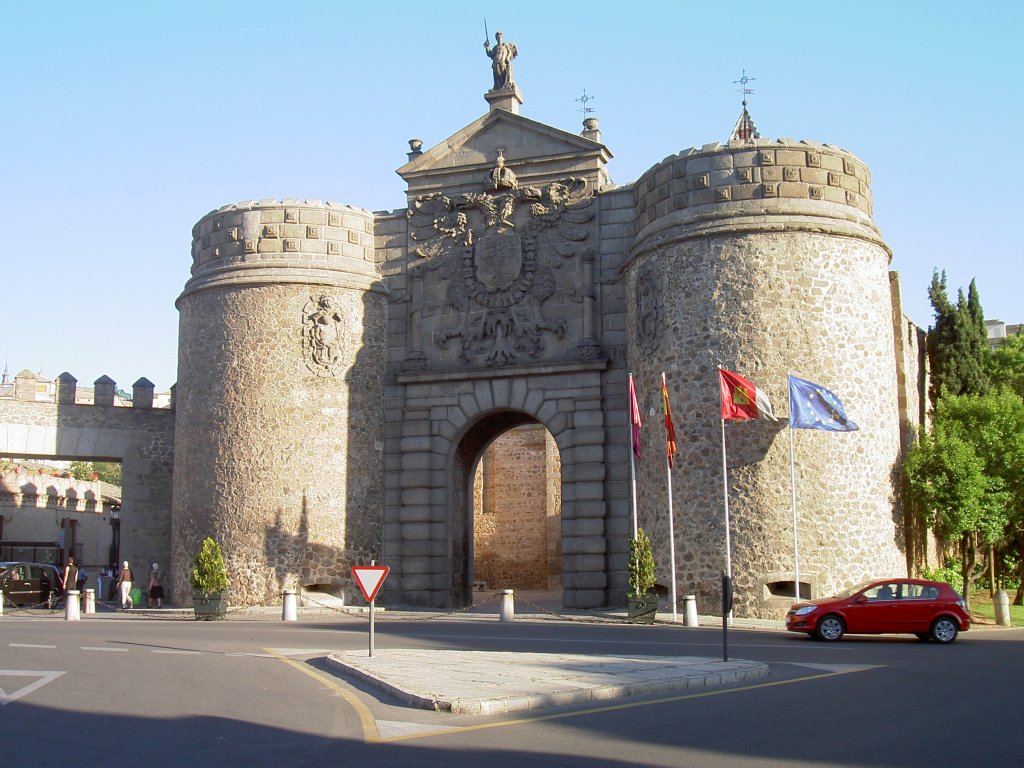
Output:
[[927, 272, 989, 408]]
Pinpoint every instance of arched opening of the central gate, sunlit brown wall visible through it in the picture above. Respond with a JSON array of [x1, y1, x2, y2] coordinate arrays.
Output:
[[450, 411, 561, 605]]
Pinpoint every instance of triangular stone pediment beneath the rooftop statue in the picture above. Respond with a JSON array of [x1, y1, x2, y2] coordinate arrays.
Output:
[[397, 110, 611, 202]]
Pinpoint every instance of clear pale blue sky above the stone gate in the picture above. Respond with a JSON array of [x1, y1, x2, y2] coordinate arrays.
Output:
[[0, 0, 1024, 389]]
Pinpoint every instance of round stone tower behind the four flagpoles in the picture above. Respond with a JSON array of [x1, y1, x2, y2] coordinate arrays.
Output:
[[625, 139, 906, 617]]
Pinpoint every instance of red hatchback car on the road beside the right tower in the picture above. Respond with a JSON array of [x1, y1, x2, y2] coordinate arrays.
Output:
[[785, 579, 971, 644]]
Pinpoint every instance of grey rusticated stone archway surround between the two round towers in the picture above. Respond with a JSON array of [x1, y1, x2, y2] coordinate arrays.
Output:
[[383, 360, 610, 608]]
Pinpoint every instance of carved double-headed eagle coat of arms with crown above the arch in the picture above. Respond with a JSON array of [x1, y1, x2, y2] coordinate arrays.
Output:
[[409, 155, 594, 366]]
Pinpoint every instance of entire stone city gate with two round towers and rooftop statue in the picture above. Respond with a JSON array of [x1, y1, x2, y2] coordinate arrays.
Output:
[[99, 36, 922, 617]]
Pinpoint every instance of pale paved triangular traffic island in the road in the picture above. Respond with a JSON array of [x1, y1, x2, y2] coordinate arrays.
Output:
[[328, 649, 768, 715]]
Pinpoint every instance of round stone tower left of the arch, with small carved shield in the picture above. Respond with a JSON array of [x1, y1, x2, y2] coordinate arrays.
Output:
[[171, 200, 385, 606]]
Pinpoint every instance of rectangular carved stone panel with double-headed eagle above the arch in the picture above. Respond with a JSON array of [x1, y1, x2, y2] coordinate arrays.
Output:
[[406, 152, 596, 371]]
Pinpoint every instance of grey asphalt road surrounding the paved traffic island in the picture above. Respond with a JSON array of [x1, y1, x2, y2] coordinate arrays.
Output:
[[0, 612, 1024, 768]]
